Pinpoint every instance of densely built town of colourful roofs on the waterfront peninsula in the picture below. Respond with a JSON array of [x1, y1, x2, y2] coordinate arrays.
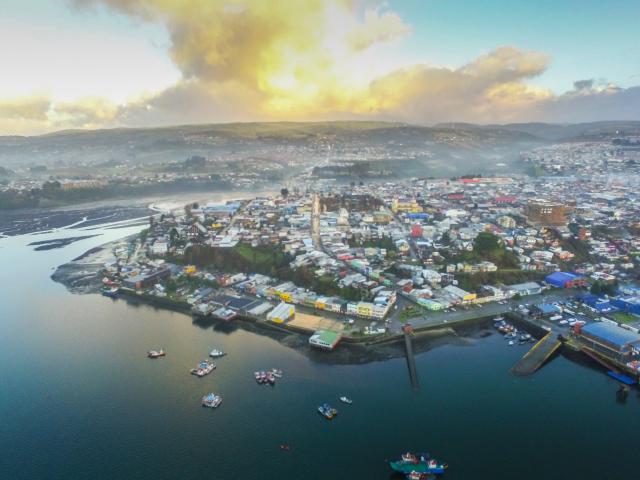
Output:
[[97, 171, 640, 380]]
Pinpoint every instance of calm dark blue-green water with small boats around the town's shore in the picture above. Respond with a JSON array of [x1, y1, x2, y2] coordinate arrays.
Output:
[[0, 218, 640, 480]]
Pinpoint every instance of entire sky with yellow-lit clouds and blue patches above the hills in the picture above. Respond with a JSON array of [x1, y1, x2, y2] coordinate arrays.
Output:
[[0, 0, 640, 135]]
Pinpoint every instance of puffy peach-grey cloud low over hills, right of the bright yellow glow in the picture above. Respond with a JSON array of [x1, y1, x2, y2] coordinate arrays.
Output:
[[368, 47, 553, 123]]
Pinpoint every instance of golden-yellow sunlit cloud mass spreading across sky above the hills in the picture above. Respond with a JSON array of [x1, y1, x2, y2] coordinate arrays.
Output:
[[0, 0, 636, 133]]
